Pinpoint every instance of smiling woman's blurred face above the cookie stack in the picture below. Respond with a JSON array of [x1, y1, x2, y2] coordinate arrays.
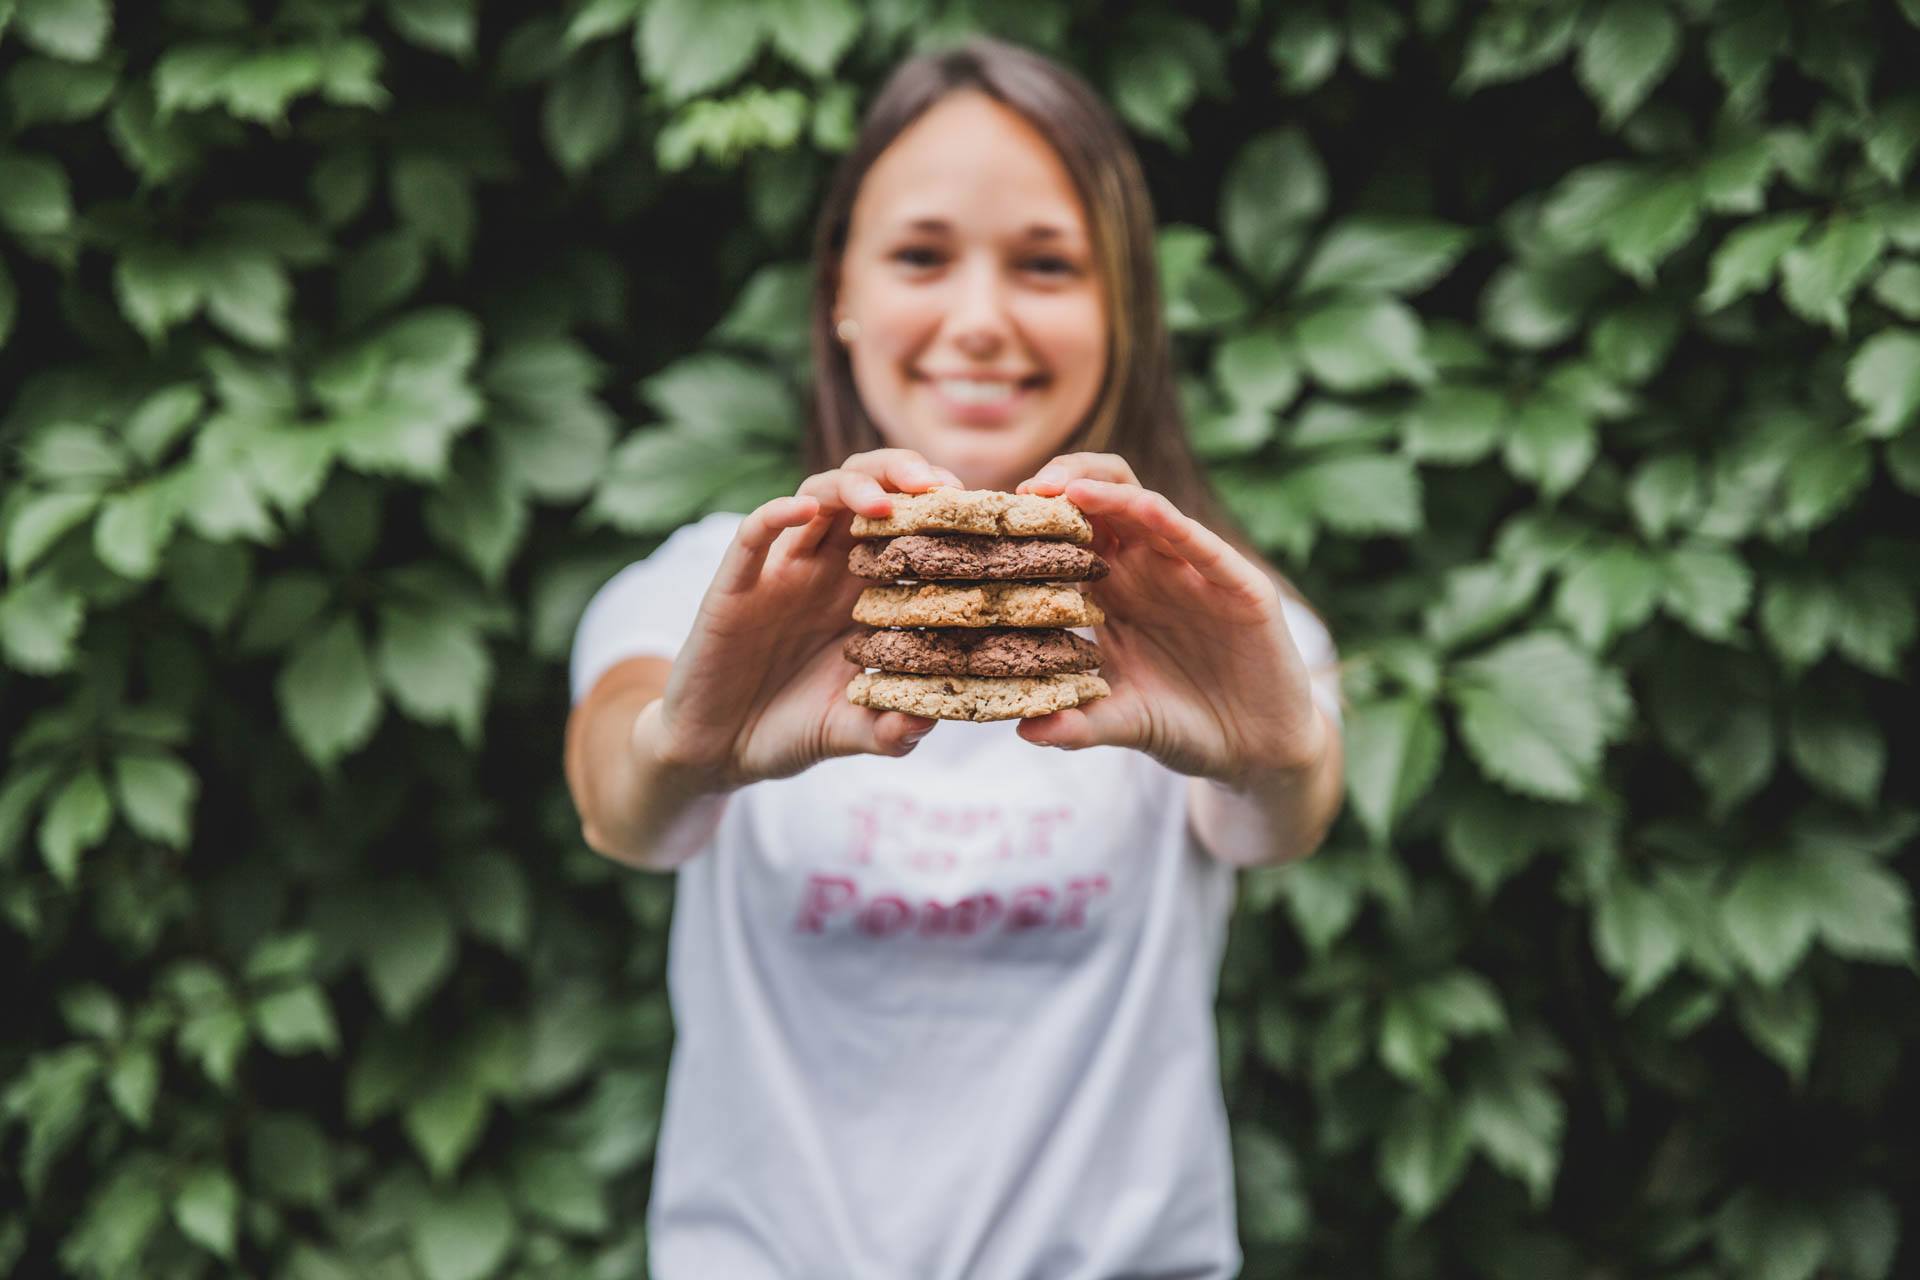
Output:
[[833, 90, 1108, 489]]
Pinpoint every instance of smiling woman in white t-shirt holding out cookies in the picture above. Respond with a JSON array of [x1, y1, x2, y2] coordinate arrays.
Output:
[[568, 40, 1340, 1280]]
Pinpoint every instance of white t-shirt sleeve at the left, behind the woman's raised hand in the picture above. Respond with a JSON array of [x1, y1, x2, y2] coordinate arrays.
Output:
[[568, 510, 743, 702]]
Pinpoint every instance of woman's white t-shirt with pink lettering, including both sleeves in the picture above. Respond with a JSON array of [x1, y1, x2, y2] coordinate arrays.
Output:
[[572, 514, 1338, 1280]]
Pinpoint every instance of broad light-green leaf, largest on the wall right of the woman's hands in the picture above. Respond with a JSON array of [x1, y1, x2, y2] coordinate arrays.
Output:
[[1450, 631, 1630, 800]]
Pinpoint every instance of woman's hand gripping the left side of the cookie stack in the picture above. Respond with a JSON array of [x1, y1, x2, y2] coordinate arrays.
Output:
[[657, 449, 960, 787]]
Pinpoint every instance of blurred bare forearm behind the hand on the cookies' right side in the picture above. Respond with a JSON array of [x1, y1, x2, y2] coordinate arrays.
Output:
[[1188, 706, 1344, 867]]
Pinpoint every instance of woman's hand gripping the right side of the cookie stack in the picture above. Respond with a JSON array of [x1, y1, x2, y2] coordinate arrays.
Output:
[[1016, 453, 1329, 783]]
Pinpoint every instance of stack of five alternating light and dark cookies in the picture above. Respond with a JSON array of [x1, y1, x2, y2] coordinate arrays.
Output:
[[845, 487, 1108, 720]]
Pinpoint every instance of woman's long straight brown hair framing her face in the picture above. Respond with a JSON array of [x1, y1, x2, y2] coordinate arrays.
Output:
[[806, 36, 1304, 621]]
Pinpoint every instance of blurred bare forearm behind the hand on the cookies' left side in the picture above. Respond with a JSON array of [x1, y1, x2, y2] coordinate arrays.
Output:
[[568, 691, 730, 871]]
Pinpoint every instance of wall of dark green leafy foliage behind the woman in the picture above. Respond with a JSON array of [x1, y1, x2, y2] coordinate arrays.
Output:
[[0, 0, 1920, 1280]]
